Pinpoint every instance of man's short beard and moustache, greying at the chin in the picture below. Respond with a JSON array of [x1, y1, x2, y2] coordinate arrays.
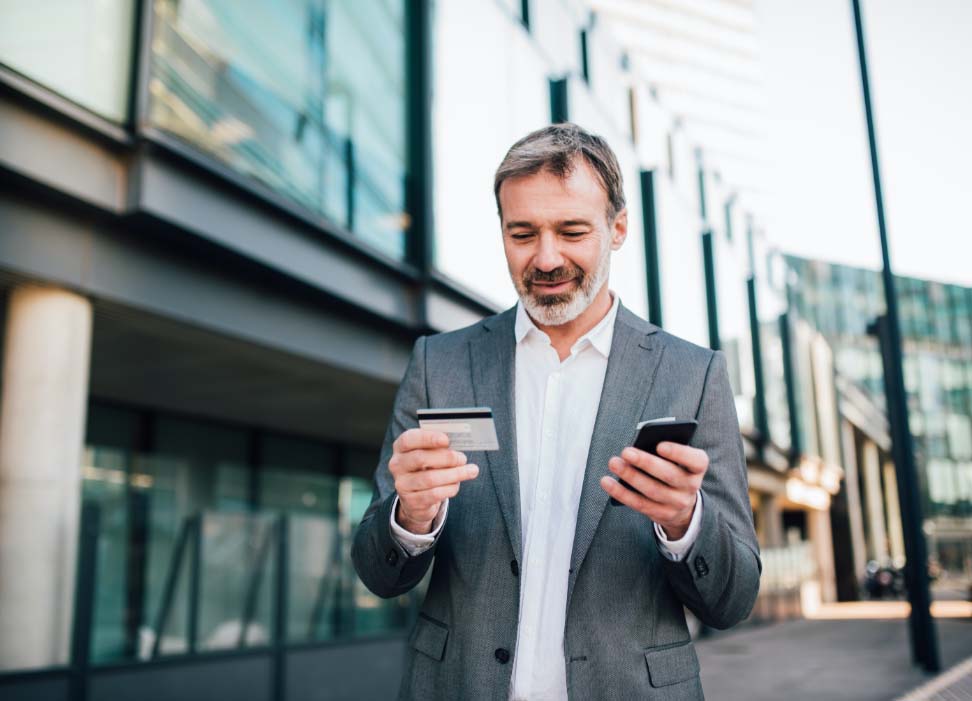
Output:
[[513, 246, 611, 326]]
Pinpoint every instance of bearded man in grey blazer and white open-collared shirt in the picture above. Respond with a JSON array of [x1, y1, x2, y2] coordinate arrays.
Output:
[[352, 124, 760, 701]]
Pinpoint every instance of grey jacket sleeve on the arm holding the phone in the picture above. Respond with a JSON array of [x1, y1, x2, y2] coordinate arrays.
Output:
[[663, 351, 762, 629]]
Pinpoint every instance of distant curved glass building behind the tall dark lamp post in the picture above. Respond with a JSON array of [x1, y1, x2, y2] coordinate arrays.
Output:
[[786, 257, 972, 588]]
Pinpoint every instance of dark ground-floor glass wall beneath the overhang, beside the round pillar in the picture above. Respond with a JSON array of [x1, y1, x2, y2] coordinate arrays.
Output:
[[83, 403, 417, 663]]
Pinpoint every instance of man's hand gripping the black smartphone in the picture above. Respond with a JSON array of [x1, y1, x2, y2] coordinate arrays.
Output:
[[601, 442, 709, 540]]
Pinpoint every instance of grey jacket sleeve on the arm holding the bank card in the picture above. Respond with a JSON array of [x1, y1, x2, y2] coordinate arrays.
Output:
[[351, 336, 441, 599]]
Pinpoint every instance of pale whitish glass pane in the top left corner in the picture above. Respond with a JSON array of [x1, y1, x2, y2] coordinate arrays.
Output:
[[0, 0, 135, 122]]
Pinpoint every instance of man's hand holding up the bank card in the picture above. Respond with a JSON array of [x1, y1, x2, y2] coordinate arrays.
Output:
[[388, 428, 479, 534]]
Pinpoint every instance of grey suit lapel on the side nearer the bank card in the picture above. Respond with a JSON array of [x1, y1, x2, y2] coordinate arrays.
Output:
[[469, 307, 523, 560]]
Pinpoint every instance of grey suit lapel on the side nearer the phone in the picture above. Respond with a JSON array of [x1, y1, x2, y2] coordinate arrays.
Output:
[[567, 305, 662, 603]]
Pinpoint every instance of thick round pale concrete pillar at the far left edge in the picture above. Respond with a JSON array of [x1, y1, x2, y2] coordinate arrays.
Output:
[[0, 285, 92, 669]]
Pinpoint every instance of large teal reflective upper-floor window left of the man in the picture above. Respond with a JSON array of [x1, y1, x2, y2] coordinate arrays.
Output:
[[149, 0, 410, 259]]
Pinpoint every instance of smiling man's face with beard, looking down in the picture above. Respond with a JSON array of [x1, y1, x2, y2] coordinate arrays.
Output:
[[499, 160, 627, 326]]
